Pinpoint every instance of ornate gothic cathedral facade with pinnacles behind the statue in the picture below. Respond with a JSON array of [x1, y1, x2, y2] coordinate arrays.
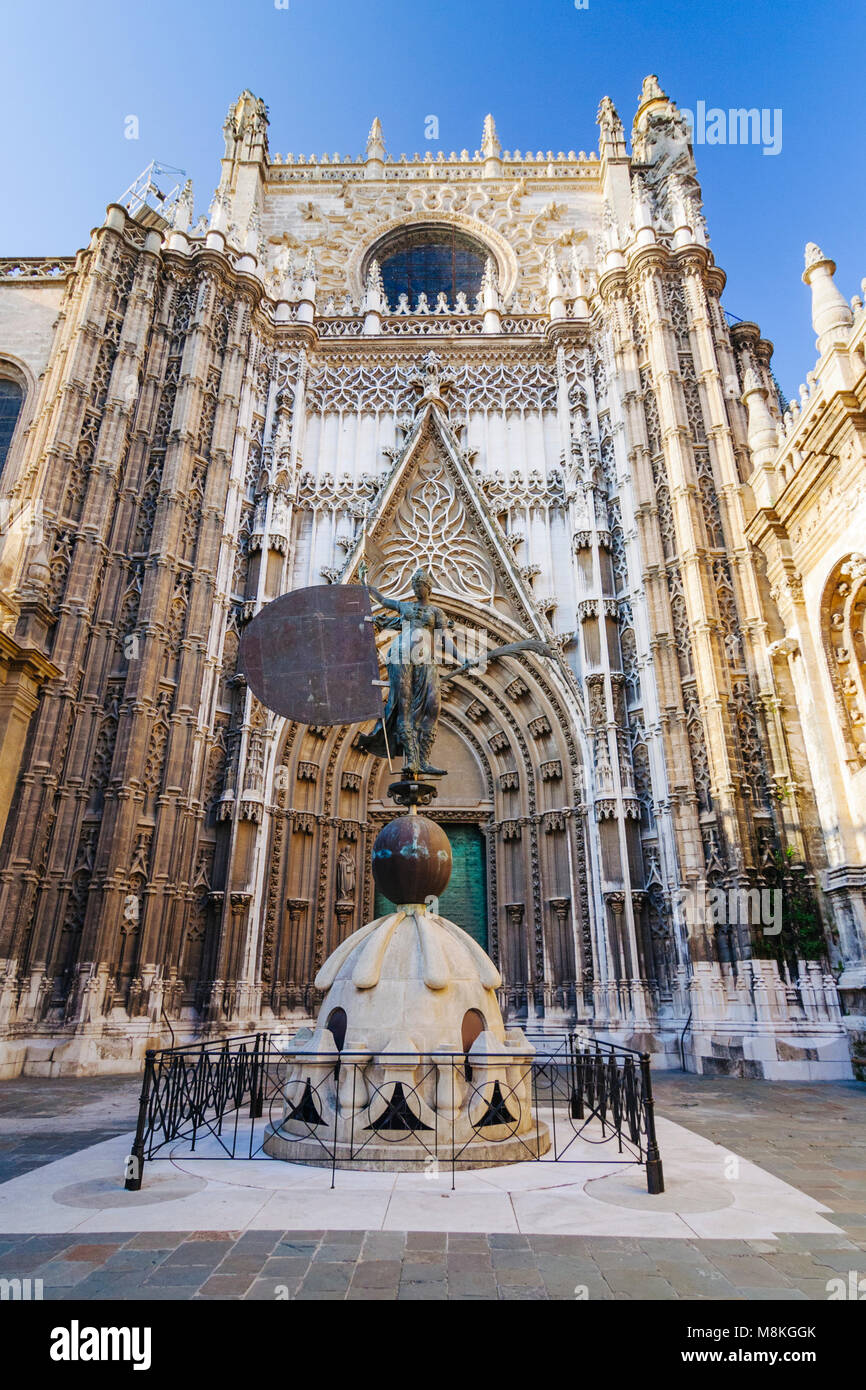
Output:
[[0, 78, 866, 1079]]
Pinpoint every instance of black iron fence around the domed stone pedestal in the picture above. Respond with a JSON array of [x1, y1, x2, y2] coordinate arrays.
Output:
[[125, 1033, 664, 1193]]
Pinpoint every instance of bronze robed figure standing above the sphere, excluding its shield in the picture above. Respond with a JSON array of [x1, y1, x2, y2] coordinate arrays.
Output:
[[357, 564, 460, 777]]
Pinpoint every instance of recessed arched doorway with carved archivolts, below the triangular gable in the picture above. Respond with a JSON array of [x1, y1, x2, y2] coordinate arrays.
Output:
[[268, 647, 594, 1017]]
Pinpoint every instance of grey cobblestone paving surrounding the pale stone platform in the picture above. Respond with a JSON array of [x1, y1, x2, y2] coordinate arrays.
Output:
[[0, 1074, 866, 1301]]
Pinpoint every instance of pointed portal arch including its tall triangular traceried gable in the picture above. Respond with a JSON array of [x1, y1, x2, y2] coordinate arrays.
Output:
[[254, 391, 599, 1016]]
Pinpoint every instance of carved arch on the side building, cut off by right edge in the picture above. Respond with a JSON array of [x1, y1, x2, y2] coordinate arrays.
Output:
[[822, 555, 866, 766]]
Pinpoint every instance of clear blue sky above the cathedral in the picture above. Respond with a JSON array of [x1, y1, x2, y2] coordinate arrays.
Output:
[[0, 0, 866, 393]]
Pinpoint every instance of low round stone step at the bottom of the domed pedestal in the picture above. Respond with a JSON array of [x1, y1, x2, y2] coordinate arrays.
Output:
[[263, 1123, 550, 1173]]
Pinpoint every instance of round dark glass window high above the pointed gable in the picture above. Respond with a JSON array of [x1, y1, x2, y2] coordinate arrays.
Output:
[[370, 227, 491, 309]]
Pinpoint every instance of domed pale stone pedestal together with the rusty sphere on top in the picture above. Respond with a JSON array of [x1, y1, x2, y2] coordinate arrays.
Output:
[[264, 812, 550, 1172]]
